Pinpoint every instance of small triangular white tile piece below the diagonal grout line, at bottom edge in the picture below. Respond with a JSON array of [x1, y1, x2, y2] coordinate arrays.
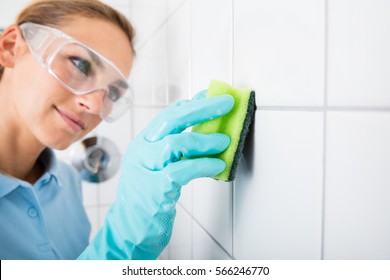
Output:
[[192, 221, 231, 260]]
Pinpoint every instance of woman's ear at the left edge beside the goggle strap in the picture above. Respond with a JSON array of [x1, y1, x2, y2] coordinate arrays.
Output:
[[0, 24, 22, 68]]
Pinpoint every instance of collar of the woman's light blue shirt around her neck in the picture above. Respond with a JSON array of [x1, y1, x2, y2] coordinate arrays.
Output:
[[0, 148, 60, 198]]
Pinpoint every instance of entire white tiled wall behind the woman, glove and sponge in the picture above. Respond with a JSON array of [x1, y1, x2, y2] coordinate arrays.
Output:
[[0, 0, 390, 259]]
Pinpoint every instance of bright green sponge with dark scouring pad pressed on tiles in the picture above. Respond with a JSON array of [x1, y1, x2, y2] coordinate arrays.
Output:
[[192, 80, 256, 182]]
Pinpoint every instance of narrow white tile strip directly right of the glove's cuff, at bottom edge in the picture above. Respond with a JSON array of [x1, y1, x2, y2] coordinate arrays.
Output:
[[168, 202, 192, 260]]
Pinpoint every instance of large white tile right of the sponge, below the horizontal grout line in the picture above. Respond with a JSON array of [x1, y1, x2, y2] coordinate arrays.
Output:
[[233, 111, 323, 259]]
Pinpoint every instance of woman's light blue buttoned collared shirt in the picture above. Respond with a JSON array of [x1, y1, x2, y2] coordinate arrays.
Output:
[[0, 149, 91, 260]]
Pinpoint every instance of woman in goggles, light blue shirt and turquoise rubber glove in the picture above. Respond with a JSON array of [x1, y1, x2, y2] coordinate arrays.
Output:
[[0, 0, 234, 259]]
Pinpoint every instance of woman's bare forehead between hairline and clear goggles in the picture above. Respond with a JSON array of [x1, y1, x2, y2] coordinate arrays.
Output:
[[58, 17, 133, 76]]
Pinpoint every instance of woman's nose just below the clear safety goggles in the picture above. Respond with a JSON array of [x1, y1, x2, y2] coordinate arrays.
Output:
[[75, 90, 105, 115]]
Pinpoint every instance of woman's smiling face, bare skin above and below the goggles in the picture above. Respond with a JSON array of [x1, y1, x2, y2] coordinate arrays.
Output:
[[12, 17, 133, 150]]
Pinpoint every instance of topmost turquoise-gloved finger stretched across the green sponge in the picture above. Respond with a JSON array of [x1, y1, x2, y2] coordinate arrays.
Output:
[[144, 94, 234, 142]]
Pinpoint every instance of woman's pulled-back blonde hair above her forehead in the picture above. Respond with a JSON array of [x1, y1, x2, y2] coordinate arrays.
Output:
[[0, 0, 135, 80]]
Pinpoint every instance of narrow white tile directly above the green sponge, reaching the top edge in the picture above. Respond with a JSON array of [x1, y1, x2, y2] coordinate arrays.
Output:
[[191, 0, 233, 94]]
